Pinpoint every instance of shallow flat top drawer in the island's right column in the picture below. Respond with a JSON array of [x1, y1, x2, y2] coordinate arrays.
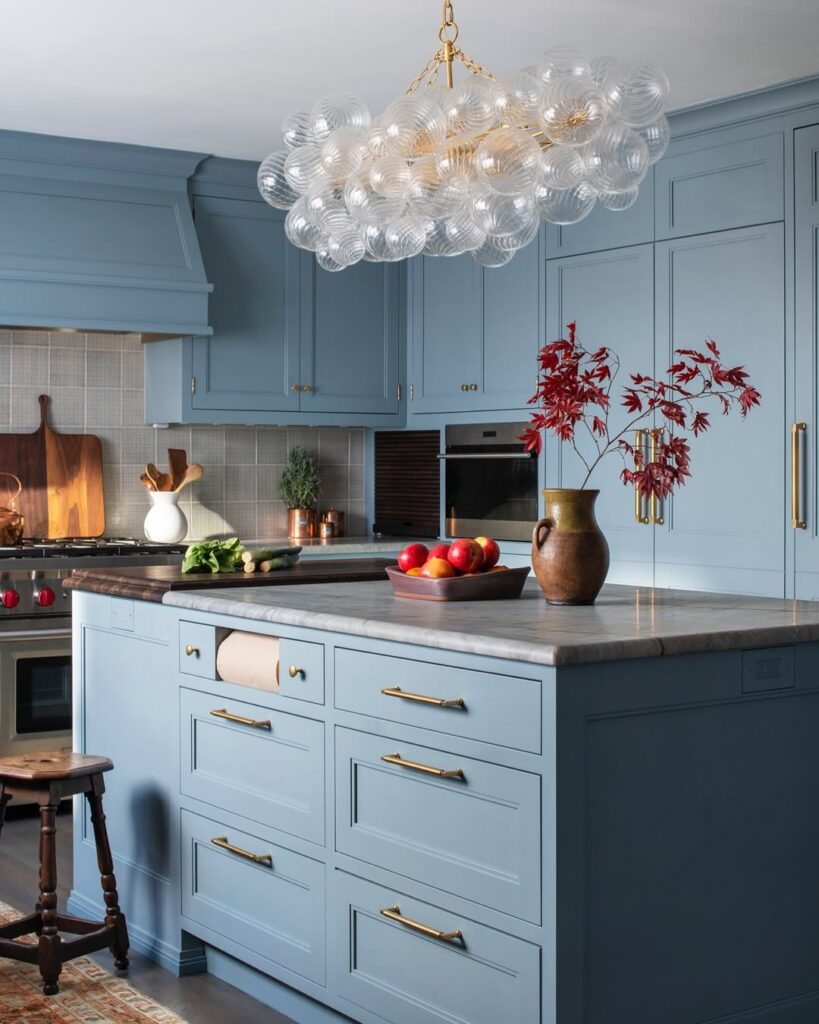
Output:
[[336, 648, 543, 754]]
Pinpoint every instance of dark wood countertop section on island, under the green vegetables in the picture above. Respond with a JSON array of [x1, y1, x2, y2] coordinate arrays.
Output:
[[62, 558, 394, 603]]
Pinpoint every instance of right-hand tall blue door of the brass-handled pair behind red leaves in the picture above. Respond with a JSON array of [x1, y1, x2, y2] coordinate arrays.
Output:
[[654, 224, 785, 597]]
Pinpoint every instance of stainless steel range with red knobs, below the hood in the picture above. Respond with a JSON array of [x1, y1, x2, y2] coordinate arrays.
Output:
[[0, 538, 185, 756]]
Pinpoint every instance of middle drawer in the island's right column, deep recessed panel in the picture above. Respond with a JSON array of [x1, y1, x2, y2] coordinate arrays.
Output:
[[336, 729, 541, 924]]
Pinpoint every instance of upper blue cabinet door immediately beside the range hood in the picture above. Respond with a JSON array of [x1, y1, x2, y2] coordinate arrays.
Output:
[[190, 197, 300, 412]]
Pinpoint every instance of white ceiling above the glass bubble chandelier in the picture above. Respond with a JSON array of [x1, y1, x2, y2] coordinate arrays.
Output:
[[0, 0, 819, 160]]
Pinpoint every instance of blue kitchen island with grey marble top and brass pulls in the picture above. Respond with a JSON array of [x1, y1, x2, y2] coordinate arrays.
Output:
[[71, 582, 819, 1024]]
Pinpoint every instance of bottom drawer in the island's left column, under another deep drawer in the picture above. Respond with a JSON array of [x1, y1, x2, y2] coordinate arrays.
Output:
[[182, 810, 325, 984]]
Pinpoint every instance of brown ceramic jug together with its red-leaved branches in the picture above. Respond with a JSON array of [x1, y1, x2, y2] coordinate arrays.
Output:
[[521, 324, 760, 604]]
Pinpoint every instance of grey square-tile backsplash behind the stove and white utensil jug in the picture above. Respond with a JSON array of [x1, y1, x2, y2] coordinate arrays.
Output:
[[0, 330, 365, 539]]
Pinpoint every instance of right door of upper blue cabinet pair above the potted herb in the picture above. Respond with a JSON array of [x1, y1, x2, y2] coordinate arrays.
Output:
[[299, 253, 400, 415]]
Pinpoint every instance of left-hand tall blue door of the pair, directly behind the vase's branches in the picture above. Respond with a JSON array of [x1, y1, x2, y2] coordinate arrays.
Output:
[[547, 245, 654, 587]]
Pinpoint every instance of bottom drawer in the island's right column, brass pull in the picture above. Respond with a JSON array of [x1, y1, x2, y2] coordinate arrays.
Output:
[[329, 871, 541, 1024]]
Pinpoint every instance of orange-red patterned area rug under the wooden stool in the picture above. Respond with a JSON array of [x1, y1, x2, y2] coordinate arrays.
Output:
[[0, 902, 185, 1024]]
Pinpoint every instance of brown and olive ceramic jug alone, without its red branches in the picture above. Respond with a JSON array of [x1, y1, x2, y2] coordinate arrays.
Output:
[[531, 487, 608, 604]]
